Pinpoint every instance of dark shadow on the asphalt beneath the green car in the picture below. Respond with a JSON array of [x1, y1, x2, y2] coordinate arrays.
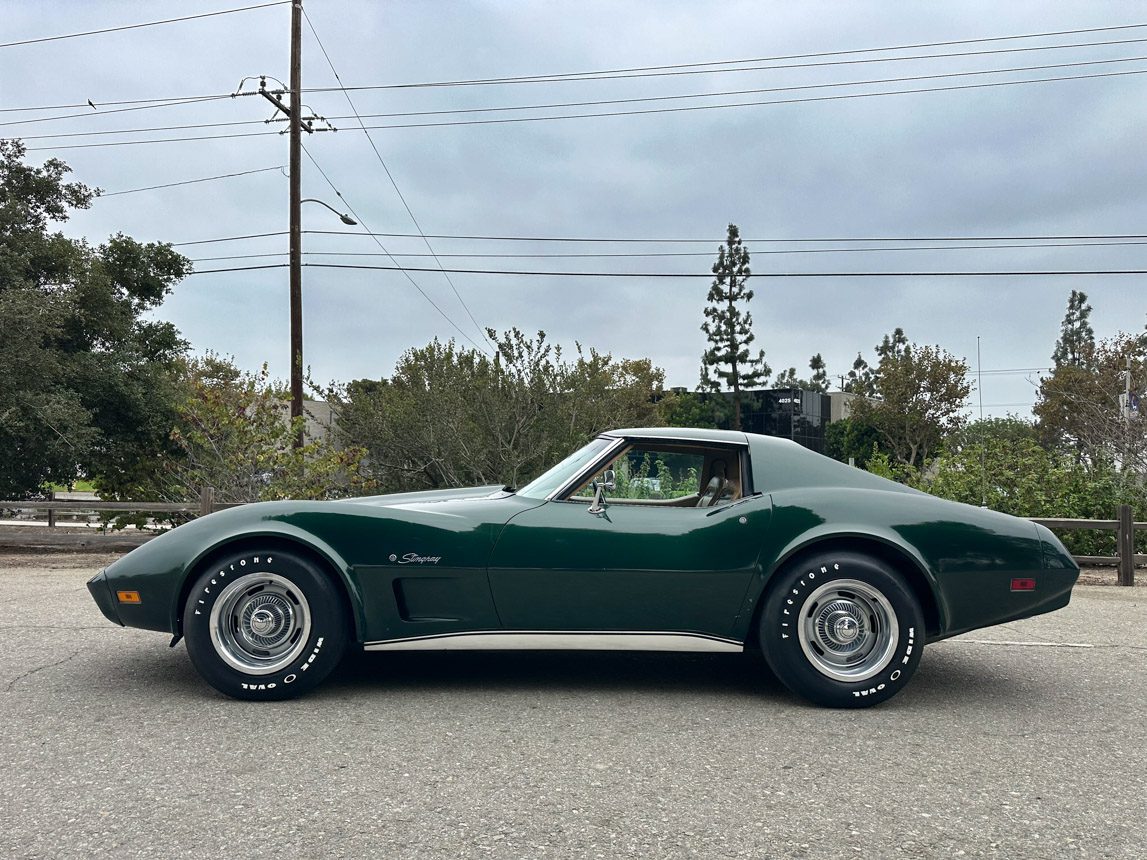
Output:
[[73, 642, 1056, 712]]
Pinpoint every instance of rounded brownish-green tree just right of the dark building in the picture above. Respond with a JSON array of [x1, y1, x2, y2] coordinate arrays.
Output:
[[852, 337, 972, 468]]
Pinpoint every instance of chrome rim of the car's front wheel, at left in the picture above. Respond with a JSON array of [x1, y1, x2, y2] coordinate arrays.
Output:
[[210, 573, 311, 675]]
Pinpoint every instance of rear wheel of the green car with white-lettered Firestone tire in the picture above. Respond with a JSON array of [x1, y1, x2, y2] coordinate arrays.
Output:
[[760, 553, 924, 707]]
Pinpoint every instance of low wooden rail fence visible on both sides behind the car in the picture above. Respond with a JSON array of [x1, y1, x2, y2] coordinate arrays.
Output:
[[0, 487, 1147, 585]]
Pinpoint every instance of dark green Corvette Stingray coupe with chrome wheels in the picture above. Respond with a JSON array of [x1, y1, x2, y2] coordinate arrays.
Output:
[[88, 428, 1079, 707]]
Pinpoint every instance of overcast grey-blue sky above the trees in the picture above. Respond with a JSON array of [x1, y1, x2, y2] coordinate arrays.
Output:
[[0, 0, 1147, 415]]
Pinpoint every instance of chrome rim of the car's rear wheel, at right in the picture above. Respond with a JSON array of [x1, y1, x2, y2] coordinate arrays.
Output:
[[797, 579, 900, 682]]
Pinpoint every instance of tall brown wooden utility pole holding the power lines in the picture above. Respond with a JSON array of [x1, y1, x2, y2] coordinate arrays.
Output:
[[290, 0, 303, 448]]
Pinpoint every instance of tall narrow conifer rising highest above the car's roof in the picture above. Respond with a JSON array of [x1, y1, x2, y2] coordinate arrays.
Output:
[[700, 224, 772, 430]]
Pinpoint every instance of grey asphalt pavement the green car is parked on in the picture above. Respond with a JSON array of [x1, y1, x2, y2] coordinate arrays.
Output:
[[0, 555, 1147, 860]]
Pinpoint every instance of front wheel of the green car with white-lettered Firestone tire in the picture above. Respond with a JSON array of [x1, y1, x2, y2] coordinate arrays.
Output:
[[184, 549, 348, 701]]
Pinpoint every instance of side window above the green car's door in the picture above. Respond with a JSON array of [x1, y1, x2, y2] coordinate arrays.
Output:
[[568, 441, 743, 508]]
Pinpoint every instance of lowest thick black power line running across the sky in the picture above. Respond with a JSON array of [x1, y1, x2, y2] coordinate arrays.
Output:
[[194, 263, 1147, 277]]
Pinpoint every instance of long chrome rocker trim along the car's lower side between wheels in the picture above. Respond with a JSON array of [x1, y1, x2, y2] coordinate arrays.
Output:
[[362, 631, 744, 654]]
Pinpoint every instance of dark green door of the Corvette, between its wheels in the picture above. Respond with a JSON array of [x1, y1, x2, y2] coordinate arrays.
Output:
[[490, 444, 771, 636]]
